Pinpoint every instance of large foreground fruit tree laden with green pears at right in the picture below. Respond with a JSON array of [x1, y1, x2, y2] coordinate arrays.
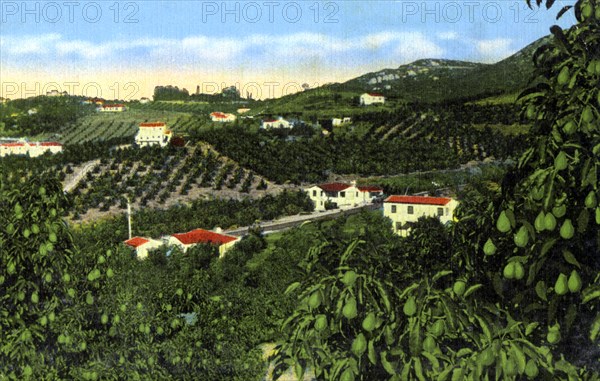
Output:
[[276, 0, 600, 381]]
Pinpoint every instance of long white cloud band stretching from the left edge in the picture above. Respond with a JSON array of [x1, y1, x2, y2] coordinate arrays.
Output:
[[0, 31, 443, 68]]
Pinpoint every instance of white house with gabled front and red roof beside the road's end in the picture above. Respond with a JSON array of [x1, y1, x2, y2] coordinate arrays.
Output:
[[305, 183, 383, 211]]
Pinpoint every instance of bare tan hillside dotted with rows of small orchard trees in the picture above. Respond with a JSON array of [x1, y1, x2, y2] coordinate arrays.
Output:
[[64, 143, 283, 219]]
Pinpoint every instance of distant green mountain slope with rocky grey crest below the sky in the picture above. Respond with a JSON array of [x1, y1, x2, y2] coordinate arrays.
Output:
[[264, 36, 550, 112]]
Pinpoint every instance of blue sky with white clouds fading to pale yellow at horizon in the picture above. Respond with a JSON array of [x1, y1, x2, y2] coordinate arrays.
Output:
[[0, 0, 573, 99]]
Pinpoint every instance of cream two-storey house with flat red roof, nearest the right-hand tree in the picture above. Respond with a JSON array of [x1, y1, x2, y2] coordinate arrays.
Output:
[[383, 196, 458, 236]]
